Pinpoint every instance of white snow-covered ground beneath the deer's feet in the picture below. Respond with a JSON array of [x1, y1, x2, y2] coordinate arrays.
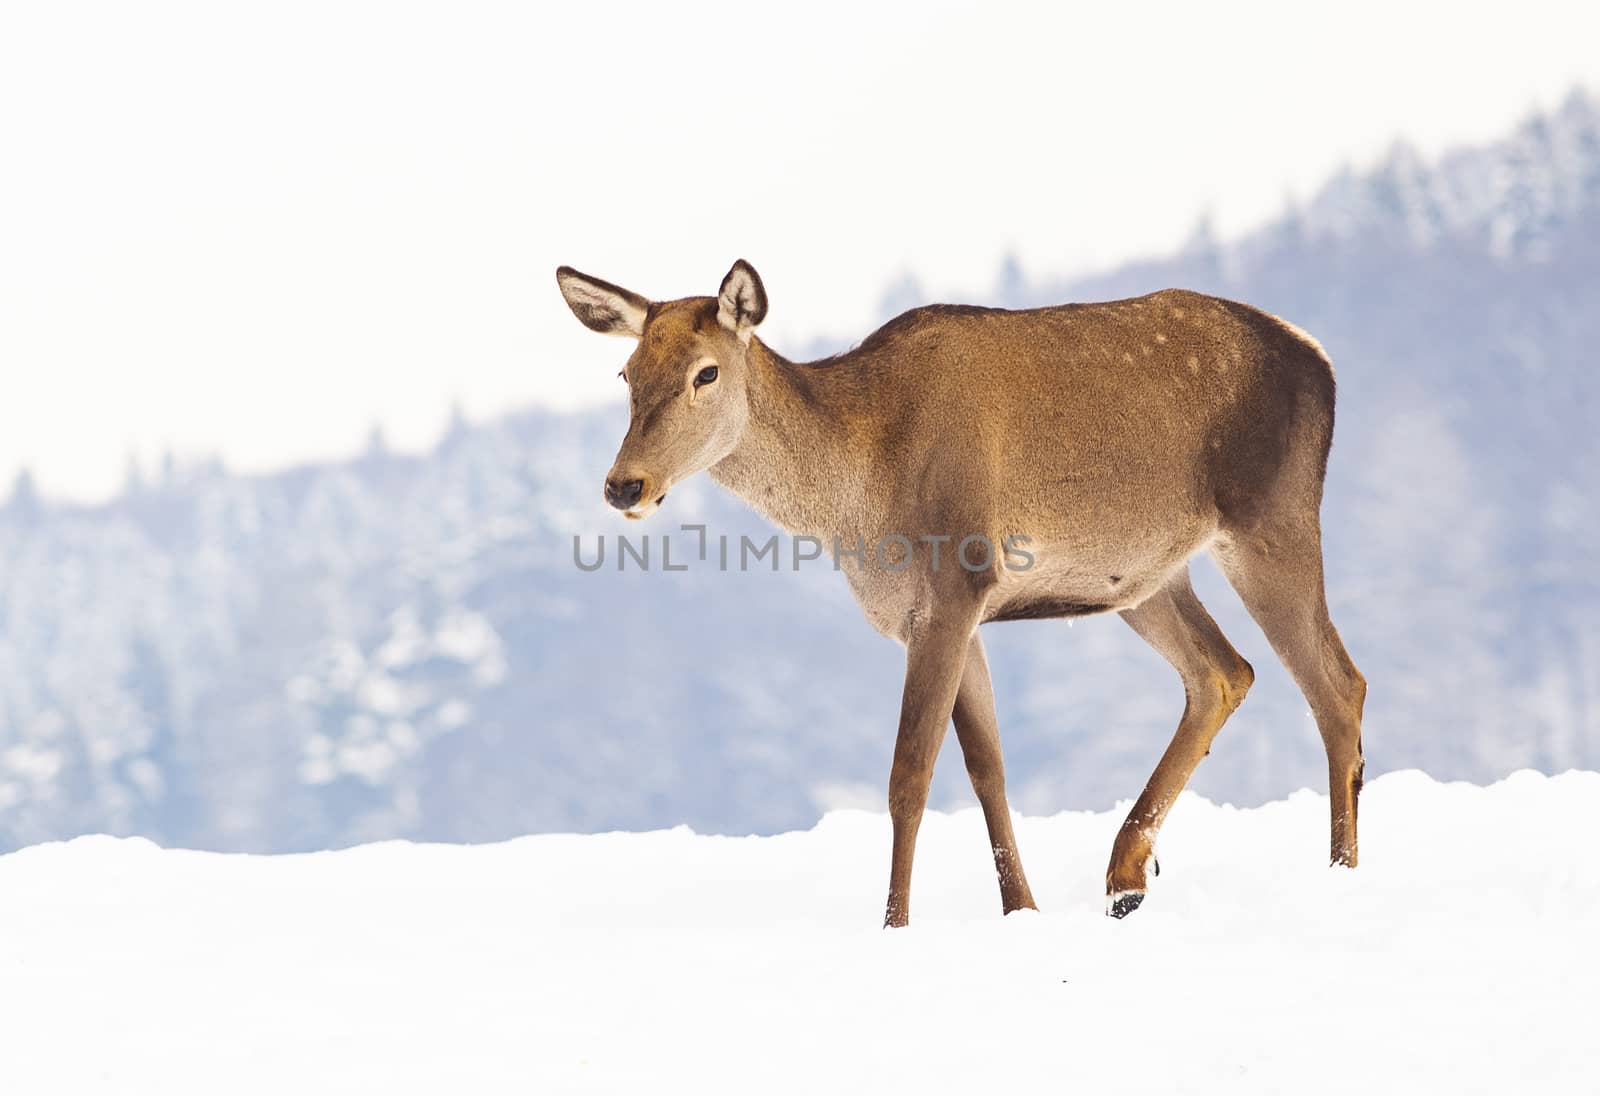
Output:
[[0, 773, 1600, 1096]]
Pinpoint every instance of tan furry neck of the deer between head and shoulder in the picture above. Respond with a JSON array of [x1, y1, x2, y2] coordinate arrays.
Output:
[[710, 338, 864, 541]]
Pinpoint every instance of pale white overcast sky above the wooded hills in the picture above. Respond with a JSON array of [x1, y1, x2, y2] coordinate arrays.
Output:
[[9, 0, 1600, 501]]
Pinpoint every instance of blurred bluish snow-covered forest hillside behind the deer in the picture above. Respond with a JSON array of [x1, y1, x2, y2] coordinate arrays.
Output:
[[0, 93, 1600, 851]]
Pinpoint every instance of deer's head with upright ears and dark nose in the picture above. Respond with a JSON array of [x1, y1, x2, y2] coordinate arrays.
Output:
[[555, 259, 766, 518]]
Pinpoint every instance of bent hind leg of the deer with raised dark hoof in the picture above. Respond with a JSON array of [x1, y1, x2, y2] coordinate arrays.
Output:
[[1106, 568, 1256, 917]]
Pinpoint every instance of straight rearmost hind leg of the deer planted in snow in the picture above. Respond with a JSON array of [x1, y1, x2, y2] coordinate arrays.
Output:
[[1213, 518, 1366, 867]]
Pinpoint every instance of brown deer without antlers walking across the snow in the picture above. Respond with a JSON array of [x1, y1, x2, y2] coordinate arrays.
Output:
[[555, 259, 1366, 925]]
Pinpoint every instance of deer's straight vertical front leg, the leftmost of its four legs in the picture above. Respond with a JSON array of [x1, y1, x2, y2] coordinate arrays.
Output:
[[883, 606, 978, 928]]
